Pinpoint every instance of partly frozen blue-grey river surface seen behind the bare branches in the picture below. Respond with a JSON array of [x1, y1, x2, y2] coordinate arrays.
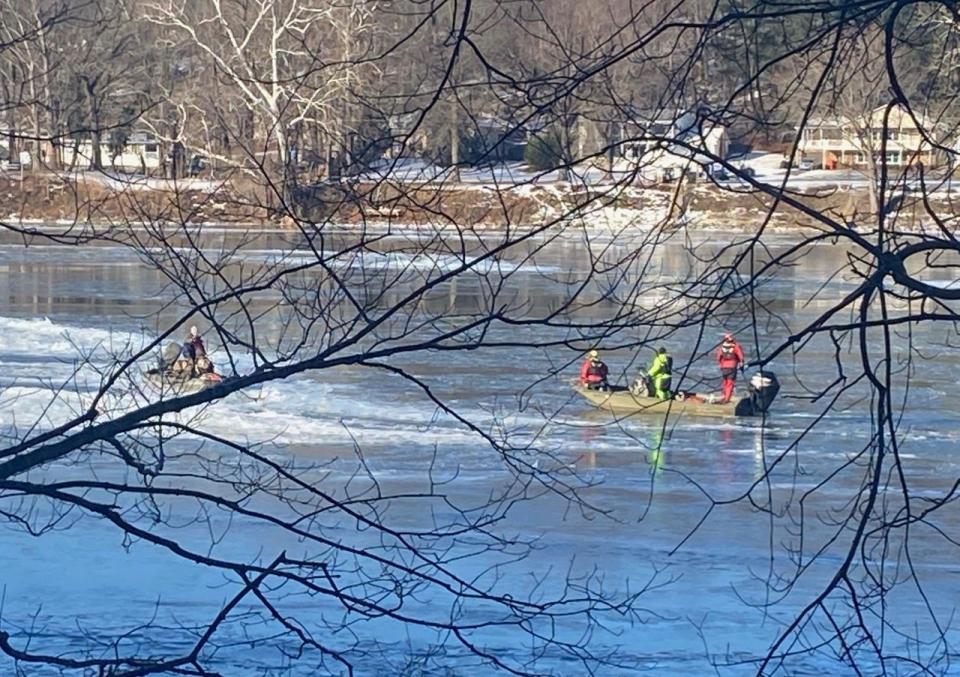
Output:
[[0, 224, 960, 675]]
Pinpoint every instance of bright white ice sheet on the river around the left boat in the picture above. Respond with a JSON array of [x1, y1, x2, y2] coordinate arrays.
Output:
[[0, 317, 510, 446]]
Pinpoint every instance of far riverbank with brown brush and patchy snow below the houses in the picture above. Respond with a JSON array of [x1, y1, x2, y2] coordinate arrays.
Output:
[[0, 167, 955, 235]]
